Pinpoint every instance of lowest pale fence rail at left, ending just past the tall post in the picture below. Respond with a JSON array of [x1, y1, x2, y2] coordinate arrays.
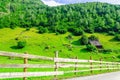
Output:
[[0, 71, 64, 79]]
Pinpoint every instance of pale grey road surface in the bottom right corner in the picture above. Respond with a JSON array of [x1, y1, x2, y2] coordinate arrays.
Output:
[[66, 71, 120, 80]]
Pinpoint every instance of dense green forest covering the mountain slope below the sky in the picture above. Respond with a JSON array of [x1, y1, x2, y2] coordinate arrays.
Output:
[[0, 0, 120, 35]]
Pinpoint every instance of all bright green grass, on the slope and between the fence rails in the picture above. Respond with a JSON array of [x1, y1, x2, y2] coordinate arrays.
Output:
[[0, 28, 120, 80]]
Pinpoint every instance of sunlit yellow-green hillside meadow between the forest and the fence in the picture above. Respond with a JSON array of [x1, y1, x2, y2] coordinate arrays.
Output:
[[0, 28, 120, 61]]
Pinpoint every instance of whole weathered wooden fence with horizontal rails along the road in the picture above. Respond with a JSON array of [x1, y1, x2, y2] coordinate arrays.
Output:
[[0, 51, 120, 80]]
